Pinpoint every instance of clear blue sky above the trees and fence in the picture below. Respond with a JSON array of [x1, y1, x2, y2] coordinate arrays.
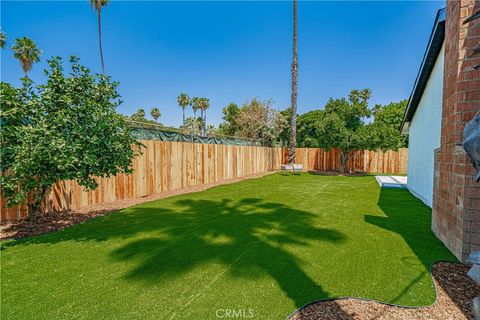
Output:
[[1, 0, 445, 126]]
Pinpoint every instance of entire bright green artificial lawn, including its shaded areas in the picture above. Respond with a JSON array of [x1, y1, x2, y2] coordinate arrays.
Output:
[[1, 174, 455, 319]]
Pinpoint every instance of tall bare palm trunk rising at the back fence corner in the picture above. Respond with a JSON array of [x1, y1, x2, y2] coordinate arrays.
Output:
[[288, 0, 298, 163]]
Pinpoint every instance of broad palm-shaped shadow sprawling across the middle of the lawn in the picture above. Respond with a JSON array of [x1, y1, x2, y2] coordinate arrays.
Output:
[[6, 198, 345, 307]]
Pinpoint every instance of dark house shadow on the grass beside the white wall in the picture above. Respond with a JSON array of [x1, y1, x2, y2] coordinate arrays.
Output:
[[365, 188, 457, 303]]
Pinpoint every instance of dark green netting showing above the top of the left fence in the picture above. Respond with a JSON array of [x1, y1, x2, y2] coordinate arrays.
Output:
[[132, 123, 266, 146]]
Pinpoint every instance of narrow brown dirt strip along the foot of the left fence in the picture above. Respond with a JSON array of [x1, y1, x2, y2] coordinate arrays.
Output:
[[0, 171, 275, 239]]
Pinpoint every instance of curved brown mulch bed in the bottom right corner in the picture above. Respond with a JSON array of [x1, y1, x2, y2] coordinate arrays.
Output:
[[290, 262, 480, 320]]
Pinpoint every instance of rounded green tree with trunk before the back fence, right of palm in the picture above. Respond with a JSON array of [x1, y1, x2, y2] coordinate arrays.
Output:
[[316, 89, 379, 173]]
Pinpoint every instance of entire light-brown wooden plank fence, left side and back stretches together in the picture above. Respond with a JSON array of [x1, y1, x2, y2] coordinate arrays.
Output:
[[0, 140, 407, 221]]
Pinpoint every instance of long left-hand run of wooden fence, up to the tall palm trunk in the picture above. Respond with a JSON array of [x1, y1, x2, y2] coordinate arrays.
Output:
[[1, 140, 282, 221]]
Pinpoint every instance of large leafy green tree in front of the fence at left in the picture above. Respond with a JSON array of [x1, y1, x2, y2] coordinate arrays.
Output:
[[0, 57, 141, 220]]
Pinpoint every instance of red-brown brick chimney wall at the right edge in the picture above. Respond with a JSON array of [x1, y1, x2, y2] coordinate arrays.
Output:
[[432, 0, 480, 260]]
